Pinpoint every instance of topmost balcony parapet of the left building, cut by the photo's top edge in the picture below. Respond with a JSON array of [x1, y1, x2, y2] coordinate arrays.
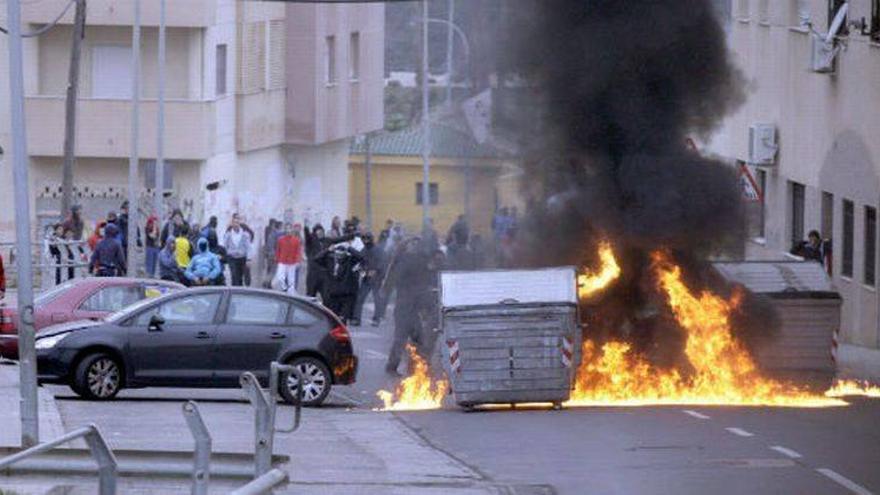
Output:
[[21, 0, 218, 27]]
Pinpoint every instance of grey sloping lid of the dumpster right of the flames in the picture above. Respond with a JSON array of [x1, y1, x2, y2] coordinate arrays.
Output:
[[712, 260, 839, 297]]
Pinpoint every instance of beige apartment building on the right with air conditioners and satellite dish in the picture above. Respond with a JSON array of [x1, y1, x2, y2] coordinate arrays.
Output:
[[711, 0, 880, 349]]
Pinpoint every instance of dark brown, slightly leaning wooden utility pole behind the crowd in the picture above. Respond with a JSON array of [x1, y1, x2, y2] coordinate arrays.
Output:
[[61, 0, 86, 219]]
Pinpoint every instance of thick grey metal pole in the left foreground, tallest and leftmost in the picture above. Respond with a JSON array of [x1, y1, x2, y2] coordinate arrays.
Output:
[[6, 0, 40, 448]]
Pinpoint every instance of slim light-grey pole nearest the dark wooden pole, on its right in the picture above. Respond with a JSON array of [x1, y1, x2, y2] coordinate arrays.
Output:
[[125, 0, 141, 275]]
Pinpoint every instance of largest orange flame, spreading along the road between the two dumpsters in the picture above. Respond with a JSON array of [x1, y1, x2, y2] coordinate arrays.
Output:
[[566, 253, 846, 407]]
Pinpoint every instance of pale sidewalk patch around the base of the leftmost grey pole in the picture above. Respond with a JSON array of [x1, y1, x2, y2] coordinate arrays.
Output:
[[0, 364, 65, 447]]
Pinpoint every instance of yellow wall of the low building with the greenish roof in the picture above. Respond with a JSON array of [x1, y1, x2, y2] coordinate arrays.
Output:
[[349, 155, 500, 239]]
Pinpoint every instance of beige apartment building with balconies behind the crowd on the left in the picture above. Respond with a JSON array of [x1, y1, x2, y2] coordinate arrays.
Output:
[[0, 0, 384, 240]]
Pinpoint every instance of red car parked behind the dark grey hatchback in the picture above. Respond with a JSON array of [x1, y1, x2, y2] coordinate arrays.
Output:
[[0, 277, 184, 359]]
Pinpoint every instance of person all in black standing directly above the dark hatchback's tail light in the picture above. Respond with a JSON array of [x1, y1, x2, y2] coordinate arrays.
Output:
[[317, 243, 363, 323]]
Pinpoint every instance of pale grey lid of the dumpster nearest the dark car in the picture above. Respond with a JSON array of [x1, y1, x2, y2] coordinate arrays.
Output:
[[440, 266, 577, 308]]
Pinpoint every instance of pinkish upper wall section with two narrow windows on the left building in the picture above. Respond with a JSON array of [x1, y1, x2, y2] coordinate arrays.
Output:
[[286, 4, 385, 144]]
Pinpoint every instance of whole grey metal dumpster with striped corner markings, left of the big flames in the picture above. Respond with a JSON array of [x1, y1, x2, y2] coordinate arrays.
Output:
[[440, 267, 581, 408]]
